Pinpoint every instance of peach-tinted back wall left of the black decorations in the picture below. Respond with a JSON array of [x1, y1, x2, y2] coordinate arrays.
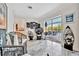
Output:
[[13, 16, 27, 35]]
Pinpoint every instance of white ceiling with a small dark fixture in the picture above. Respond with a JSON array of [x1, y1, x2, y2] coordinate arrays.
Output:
[[7, 3, 60, 18]]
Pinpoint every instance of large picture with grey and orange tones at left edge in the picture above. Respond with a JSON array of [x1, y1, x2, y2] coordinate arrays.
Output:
[[0, 3, 7, 29]]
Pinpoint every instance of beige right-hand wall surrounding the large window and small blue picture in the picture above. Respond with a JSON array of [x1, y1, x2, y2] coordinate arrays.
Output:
[[39, 3, 79, 51]]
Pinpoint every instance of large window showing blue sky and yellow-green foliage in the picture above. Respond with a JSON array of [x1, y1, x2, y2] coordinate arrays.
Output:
[[45, 16, 63, 35]]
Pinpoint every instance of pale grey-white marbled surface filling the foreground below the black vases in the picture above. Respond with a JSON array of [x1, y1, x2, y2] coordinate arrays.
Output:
[[27, 40, 79, 56]]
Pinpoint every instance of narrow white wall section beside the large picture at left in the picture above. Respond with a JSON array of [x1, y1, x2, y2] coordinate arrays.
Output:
[[6, 6, 14, 45]]
